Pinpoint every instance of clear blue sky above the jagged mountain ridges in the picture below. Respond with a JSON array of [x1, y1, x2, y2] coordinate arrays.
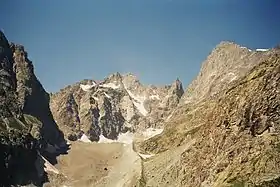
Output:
[[0, 0, 280, 92]]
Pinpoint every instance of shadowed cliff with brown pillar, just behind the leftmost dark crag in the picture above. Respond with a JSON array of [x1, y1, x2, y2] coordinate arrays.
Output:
[[10, 43, 63, 145]]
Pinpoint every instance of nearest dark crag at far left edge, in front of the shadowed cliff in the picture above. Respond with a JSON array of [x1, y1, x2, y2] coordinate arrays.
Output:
[[0, 32, 42, 186]]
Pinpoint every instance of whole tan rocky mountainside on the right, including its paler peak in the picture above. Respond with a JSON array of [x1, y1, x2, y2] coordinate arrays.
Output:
[[138, 43, 280, 187]]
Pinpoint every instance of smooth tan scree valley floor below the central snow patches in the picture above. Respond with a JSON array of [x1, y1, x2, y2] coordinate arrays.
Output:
[[46, 142, 141, 187]]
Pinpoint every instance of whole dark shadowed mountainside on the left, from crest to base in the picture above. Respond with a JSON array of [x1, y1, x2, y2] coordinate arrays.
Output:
[[0, 32, 63, 186]]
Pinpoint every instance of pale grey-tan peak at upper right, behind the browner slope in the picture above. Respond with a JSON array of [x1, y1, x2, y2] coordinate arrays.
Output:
[[180, 42, 274, 105]]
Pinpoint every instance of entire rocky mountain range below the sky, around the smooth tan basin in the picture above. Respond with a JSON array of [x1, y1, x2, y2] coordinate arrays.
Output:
[[0, 32, 280, 187]]
